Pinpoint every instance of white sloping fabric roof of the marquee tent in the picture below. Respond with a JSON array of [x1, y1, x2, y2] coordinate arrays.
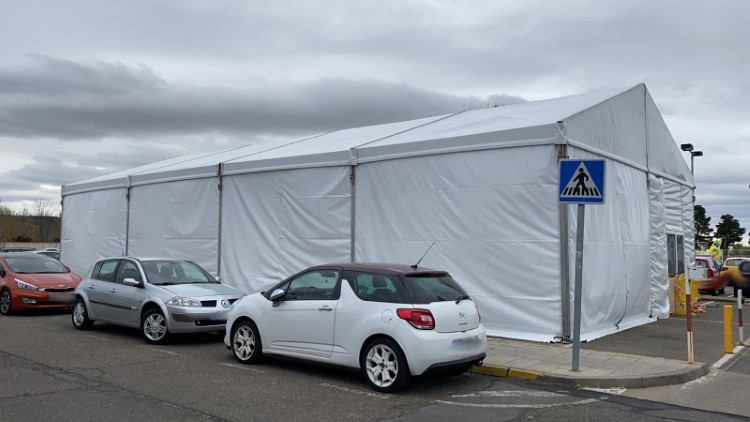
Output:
[[62, 84, 688, 196]]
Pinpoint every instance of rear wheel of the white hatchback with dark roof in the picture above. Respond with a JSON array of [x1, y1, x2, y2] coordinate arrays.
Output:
[[360, 338, 411, 393]]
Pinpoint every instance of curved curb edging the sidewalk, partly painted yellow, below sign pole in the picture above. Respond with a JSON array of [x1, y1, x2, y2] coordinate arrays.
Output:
[[471, 362, 711, 388]]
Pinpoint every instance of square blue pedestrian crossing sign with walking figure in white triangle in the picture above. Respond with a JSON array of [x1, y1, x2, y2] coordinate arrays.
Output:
[[559, 160, 604, 204]]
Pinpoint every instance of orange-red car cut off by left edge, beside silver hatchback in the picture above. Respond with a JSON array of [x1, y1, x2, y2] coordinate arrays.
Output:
[[0, 252, 81, 315]]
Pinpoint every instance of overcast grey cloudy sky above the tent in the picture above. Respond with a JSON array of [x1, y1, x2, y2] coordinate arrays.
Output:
[[0, 0, 750, 242]]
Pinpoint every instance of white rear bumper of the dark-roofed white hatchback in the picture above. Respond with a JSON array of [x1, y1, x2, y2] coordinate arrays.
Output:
[[399, 325, 487, 375]]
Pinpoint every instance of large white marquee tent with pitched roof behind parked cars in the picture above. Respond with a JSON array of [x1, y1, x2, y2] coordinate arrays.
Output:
[[61, 84, 693, 341]]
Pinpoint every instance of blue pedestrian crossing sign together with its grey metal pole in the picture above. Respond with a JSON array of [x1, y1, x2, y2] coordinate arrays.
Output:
[[559, 160, 605, 371]]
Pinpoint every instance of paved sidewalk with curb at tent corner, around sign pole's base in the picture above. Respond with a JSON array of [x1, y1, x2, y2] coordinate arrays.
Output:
[[472, 294, 750, 388]]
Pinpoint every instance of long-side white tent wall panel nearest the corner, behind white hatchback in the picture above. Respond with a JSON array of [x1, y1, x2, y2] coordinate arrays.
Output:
[[355, 145, 561, 341]]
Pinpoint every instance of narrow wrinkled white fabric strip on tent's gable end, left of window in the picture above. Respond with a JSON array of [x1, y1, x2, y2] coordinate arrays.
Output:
[[648, 175, 670, 318]]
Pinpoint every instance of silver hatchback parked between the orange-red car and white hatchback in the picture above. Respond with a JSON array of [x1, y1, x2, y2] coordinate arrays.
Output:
[[72, 257, 244, 344]]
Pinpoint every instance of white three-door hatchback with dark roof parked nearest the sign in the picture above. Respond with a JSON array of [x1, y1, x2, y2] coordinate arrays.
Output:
[[224, 264, 487, 393]]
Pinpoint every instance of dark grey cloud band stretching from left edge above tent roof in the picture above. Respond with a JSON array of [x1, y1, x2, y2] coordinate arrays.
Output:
[[0, 56, 523, 140]]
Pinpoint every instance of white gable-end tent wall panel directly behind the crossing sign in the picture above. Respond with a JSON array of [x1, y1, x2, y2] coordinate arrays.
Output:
[[569, 149, 651, 340]]
